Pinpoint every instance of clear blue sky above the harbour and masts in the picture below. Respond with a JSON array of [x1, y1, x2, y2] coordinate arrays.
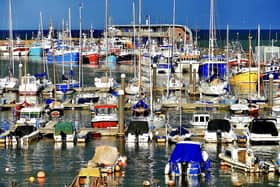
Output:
[[0, 0, 280, 30]]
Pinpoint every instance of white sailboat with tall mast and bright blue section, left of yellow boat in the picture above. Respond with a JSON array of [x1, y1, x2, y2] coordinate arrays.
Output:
[[199, 0, 228, 96]]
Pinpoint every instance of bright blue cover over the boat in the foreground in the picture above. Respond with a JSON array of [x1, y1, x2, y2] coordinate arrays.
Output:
[[169, 141, 204, 163]]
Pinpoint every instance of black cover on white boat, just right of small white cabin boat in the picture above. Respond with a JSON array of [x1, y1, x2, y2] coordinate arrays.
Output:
[[207, 119, 230, 132]]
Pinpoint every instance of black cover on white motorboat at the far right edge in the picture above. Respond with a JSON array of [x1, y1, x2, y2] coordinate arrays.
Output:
[[249, 120, 278, 136]]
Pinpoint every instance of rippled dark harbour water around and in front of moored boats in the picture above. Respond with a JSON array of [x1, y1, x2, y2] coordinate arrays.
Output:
[[0, 59, 280, 187]]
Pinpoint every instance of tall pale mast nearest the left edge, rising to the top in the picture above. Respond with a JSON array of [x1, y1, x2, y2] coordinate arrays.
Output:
[[9, 0, 15, 77]]
